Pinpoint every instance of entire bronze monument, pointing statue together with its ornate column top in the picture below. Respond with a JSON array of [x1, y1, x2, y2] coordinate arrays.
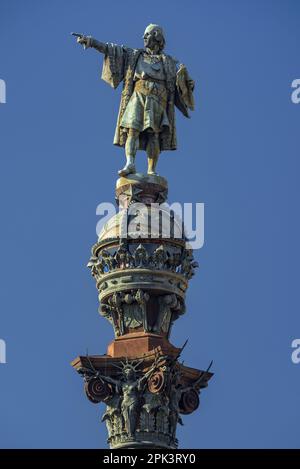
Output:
[[72, 24, 212, 449]]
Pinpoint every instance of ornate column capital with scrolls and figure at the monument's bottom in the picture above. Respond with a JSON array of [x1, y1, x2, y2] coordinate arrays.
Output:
[[81, 354, 209, 448]]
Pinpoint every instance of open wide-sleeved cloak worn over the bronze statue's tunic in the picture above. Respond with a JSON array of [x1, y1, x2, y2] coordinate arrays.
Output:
[[101, 44, 194, 151]]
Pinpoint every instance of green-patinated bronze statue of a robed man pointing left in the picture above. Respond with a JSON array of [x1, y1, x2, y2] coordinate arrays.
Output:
[[73, 24, 194, 176]]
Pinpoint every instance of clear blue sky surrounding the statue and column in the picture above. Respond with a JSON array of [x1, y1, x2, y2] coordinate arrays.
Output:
[[0, 0, 300, 448]]
